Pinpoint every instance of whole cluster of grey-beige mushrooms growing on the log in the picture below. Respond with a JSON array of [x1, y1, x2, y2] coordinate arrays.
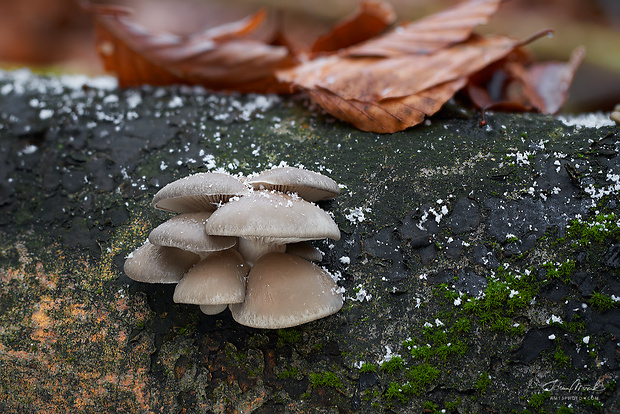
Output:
[[124, 167, 342, 329]]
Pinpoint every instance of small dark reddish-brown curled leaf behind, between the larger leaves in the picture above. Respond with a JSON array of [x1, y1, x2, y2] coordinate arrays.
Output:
[[312, 0, 396, 53]]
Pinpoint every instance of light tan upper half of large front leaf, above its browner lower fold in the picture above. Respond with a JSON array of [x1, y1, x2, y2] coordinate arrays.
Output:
[[277, 36, 520, 102]]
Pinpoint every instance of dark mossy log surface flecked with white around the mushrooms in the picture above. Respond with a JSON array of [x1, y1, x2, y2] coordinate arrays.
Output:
[[0, 72, 620, 413]]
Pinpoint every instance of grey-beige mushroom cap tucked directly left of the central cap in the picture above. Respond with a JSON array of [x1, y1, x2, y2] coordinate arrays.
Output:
[[149, 211, 237, 253]]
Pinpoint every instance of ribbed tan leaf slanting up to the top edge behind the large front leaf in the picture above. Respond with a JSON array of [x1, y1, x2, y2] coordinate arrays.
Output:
[[341, 0, 502, 57]]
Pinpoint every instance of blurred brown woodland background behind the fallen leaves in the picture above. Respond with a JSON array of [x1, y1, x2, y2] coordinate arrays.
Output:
[[0, 0, 620, 113]]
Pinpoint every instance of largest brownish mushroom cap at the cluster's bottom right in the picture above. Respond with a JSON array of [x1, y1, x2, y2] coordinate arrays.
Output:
[[229, 253, 343, 329]]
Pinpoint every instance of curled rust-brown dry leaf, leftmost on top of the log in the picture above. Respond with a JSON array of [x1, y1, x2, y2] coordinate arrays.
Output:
[[92, 6, 292, 92]]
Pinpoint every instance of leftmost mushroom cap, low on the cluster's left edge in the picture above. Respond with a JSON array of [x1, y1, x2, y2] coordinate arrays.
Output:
[[124, 240, 200, 283]]
